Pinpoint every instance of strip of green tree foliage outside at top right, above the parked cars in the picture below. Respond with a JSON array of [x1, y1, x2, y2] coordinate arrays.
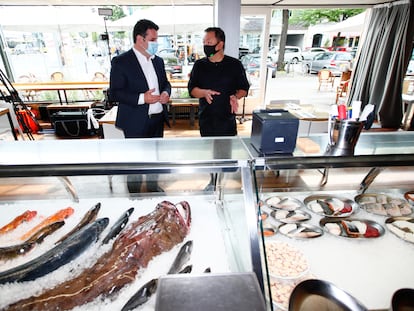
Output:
[[289, 9, 364, 27]]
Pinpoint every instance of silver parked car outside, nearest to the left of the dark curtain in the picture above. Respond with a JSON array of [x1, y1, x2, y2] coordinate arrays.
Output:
[[302, 52, 354, 76]]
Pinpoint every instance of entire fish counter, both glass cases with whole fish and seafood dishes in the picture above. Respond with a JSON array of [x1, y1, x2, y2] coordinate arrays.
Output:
[[0, 132, 414, 310]]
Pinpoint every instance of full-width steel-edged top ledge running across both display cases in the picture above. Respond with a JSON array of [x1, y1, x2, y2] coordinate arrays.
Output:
[[0, 132, 414, 177]]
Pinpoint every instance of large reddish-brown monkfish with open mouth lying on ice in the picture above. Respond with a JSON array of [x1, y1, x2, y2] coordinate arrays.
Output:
[[7, 201, 191, 311]]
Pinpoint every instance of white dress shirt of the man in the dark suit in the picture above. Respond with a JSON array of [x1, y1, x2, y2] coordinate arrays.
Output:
[[132, 48, 162, 115]]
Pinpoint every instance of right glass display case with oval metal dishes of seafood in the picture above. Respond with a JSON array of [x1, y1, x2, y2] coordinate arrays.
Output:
[[251, 132, 414, 310]]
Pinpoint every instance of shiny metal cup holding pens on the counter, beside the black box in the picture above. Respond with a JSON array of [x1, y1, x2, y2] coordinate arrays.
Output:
[[326, 119, 364, 156]]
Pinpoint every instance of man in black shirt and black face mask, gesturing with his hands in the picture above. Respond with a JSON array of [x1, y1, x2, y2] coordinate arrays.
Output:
[[188, 27, 249, 190]]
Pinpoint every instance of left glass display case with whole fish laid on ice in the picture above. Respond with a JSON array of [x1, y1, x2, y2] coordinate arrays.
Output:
[[0, 137, 264, 310]]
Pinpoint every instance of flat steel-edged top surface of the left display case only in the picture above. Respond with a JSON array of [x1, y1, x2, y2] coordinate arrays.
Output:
[[0, 137, 250, 177]]
